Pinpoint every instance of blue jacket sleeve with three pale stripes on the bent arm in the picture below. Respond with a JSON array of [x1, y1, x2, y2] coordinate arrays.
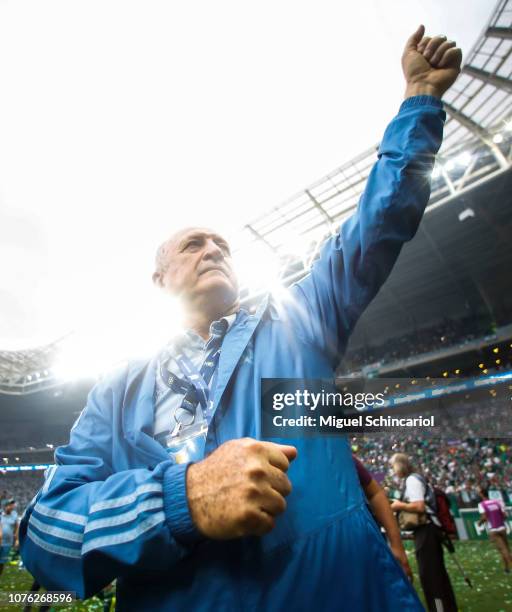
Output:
[[20, 376, 204, 598]]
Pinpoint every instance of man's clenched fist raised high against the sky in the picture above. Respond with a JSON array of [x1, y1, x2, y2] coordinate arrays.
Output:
[[402, 26, 462, 98]]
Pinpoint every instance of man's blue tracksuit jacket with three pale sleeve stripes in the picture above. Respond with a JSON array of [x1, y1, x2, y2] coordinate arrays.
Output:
[[20, 96, 445, 612]]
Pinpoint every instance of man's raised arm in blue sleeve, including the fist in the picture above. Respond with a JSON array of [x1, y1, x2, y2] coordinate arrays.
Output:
[[290, 26, 461, 364]]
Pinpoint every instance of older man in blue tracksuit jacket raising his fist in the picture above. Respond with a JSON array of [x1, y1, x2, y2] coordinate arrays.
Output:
[[21, 26, 461, 611]]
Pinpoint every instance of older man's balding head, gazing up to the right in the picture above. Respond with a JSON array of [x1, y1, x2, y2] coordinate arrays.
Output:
[[153, 228, 238, 305]]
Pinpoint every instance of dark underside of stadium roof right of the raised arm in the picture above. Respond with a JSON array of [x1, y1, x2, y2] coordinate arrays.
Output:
[[347, 169, 512, 352]]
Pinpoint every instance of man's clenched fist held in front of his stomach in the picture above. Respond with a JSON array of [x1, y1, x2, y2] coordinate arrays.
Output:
[[187, 438, 297, 540]]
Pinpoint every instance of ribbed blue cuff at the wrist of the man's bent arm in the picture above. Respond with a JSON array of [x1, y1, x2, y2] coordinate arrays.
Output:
[[162, 463, 204, 544]]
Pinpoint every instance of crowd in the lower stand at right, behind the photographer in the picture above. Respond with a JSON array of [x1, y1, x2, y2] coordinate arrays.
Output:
[[351, 392, 512, 507]]
